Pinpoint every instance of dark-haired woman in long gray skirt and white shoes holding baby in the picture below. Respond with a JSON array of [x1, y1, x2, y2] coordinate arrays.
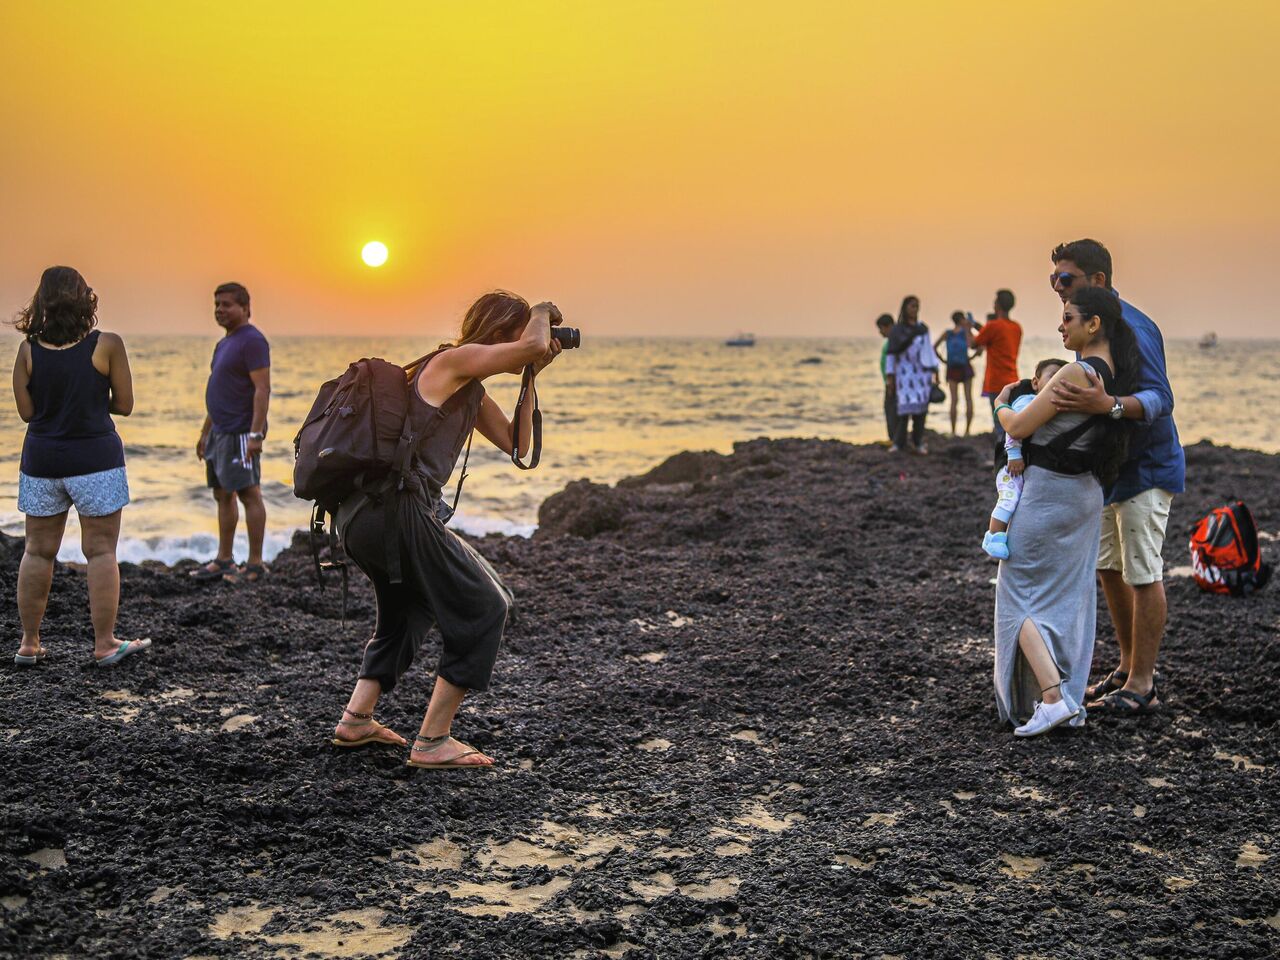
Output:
[[995, 287, 1139, 736]]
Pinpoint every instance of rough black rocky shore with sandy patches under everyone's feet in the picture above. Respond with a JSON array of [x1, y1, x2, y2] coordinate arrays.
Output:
[[0, 438, 1280, 957]]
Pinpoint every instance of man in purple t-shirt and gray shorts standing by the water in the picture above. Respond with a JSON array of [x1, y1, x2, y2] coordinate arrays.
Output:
[[192, 283, 271, 582]]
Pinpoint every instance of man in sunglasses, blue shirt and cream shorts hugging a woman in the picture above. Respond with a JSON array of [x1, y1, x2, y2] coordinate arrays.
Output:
[[1050, 239, 1187, 716]]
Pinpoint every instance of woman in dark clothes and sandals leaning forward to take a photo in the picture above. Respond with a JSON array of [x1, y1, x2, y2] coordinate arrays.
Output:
[[333, 292, 561, 769]]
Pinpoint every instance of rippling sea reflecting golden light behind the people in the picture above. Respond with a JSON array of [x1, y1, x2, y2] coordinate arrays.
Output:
[[0, 329, 1280, 563]]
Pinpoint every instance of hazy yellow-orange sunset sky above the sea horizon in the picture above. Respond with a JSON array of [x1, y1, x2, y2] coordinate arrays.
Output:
[[0, 0, 1280, 335]]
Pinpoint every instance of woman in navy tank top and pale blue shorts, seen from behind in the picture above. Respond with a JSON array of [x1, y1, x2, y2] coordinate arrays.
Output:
[[13, 266, 151, 667]]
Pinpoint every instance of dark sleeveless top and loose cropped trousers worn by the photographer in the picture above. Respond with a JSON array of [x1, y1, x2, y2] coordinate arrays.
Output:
[[337, 378, 512, 692]]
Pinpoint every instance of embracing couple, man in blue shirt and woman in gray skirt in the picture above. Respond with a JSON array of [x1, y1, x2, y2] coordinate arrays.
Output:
[[995, 239, 1184, 736]]
